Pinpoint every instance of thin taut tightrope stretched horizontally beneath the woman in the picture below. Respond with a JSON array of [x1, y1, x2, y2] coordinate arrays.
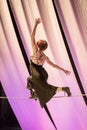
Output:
[[0, 94, 87, 99]]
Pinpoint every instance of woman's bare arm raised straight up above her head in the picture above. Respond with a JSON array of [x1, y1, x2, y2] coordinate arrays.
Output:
[[31, 18, 41, 52]]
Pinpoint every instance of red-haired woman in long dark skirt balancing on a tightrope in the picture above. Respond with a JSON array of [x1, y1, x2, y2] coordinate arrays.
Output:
[[27, 18, 71, 107]]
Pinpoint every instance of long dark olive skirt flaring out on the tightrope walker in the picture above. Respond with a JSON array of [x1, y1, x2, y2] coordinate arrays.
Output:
[[30, 61, 57, 107]]
